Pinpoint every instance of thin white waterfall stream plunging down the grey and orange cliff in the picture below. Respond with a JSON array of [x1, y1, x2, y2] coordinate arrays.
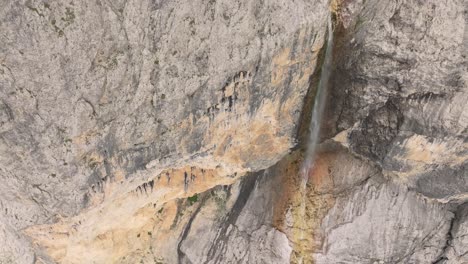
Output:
[[299, 9, 333, 263]]
